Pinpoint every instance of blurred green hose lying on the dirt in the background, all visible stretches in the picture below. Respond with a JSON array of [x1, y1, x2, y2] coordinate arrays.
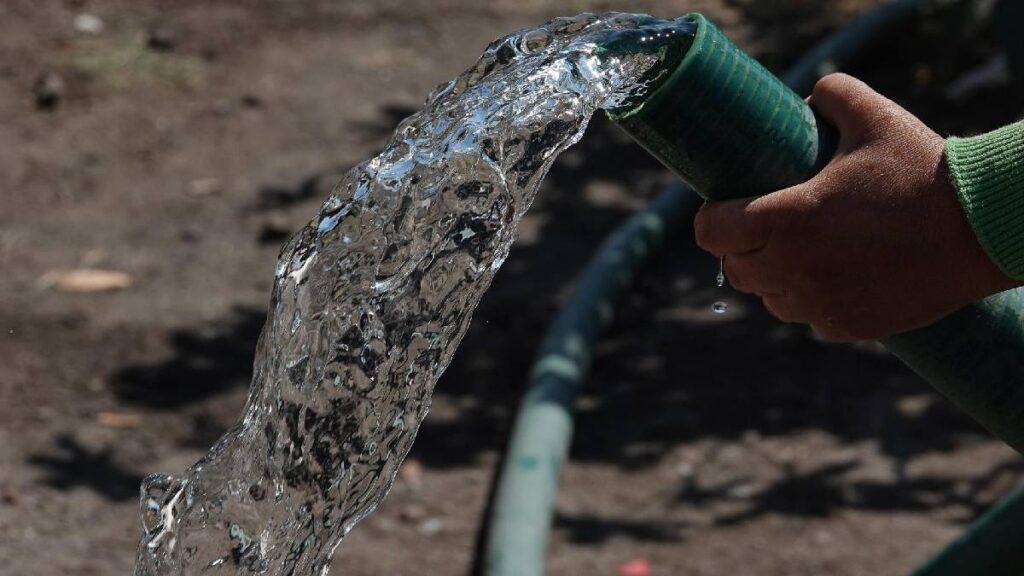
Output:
[[483, 0, 1024, 576]]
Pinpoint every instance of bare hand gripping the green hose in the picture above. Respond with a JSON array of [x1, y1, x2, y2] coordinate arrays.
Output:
[[694, 74, 1024, 341]]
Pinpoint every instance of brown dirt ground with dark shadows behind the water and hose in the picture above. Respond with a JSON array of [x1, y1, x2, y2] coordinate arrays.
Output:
[[0, 0, 1024, 576]]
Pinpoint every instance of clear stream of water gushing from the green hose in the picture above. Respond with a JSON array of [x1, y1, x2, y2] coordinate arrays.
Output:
[[134, 13, 693, 576]]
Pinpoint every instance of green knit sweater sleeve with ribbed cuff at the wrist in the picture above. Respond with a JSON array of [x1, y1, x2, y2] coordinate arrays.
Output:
[[946, 121, 1024, 280]]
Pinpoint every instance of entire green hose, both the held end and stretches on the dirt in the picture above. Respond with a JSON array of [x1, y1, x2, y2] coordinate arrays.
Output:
[[484, 0, 1024, 576]]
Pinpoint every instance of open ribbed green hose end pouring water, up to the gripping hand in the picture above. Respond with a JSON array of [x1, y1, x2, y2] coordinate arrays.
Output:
[[609, 13, 837, 200]]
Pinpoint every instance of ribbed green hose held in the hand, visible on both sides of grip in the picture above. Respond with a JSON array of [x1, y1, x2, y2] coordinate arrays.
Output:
[[613, 8, 1024, 452]]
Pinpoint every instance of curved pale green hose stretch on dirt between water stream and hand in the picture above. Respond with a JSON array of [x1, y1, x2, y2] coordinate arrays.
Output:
[[483, 183, 700, 576]]
